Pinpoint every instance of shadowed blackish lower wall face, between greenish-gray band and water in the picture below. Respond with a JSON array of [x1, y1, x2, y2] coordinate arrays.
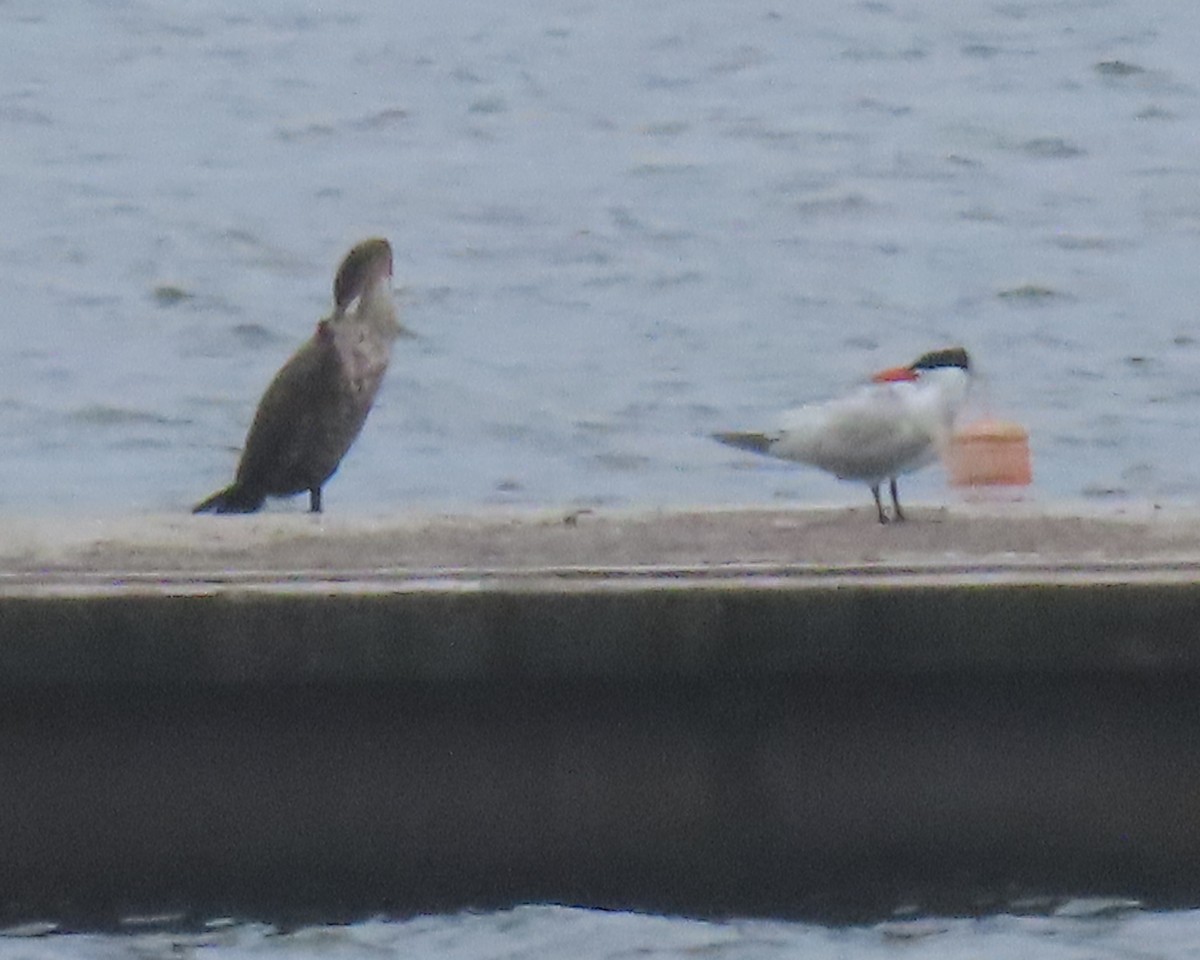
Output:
[[0, 673, 1200, 923]]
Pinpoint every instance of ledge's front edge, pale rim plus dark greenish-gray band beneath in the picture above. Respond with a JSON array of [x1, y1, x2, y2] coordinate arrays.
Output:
[[0, 564, 1200, 689]]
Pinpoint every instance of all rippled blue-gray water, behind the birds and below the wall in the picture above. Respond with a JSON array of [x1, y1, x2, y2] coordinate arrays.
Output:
[[0, 0, 1200, 958]]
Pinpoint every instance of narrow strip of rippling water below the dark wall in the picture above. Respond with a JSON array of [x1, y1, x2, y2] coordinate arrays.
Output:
[[0, 900, 1200, 960]]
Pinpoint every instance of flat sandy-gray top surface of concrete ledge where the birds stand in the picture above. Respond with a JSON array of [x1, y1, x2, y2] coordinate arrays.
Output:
[[0, 503, 1200, 577]]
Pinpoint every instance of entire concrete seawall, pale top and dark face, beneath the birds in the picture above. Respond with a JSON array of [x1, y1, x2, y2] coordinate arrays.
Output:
[[0, 506, 1200, 922]]
